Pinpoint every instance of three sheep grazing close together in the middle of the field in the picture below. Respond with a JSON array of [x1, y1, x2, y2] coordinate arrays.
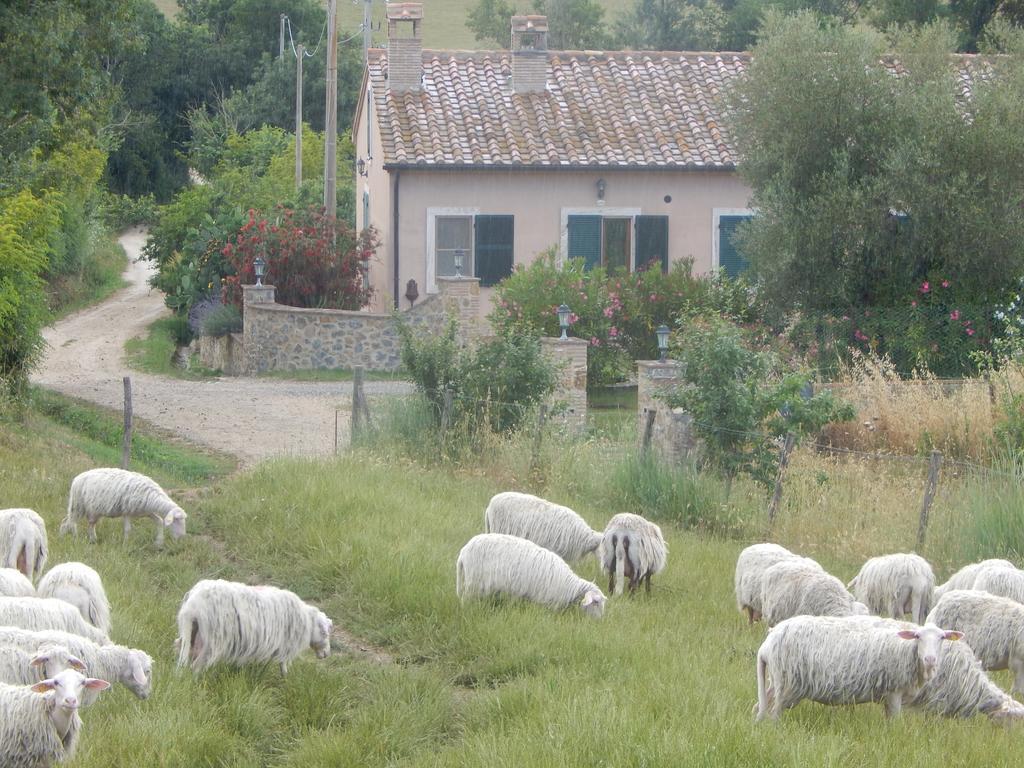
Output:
[[456, 492, 669, 618]]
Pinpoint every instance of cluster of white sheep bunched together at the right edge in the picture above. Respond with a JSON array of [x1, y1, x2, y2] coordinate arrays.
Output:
[[734, 544, 1024, 721]]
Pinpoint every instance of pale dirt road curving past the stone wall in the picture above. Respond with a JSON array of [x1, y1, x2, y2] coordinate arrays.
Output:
[[33, 229, 408, 465]]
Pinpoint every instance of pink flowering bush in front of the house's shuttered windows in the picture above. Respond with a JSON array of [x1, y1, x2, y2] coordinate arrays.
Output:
[[490, 249, 754, 385]]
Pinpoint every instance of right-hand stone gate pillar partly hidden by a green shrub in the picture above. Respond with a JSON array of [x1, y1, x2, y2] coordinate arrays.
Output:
[[637, 360, 697, 464]]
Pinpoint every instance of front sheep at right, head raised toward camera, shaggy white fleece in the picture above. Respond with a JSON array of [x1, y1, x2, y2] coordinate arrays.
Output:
[[757, 616, 962, 720]]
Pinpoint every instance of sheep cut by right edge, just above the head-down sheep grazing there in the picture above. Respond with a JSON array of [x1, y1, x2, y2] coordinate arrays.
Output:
[[928, 590, 1024, 693]]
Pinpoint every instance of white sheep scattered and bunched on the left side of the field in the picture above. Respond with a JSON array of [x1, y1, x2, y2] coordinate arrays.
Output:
[[0, 469, 333, 768]]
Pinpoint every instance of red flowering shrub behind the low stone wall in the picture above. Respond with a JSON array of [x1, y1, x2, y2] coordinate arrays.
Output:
[[222, 207, 379, 309]]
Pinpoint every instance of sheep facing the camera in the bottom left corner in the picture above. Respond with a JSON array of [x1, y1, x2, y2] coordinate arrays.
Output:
[[0, 670, 111, 768]]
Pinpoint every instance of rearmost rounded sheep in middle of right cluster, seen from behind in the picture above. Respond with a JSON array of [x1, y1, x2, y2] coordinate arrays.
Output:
[[847, 553, 935, 624]]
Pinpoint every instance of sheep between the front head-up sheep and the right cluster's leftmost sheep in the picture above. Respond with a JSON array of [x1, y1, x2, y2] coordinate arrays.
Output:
[[761, 557, 868, 627]]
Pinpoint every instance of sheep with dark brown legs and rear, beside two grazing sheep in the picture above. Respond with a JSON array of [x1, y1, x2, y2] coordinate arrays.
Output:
[[598, 512, 669, 595]]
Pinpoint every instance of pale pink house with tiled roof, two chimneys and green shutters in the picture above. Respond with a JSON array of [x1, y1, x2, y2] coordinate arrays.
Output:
[[353, 3, 751, 314]]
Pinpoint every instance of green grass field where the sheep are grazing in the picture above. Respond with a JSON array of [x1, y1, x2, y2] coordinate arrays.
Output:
[[0, 391, 1019, 768]]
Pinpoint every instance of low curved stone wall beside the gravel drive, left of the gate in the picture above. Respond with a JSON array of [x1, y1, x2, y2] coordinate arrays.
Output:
[[240, 278, 481, 375]]
